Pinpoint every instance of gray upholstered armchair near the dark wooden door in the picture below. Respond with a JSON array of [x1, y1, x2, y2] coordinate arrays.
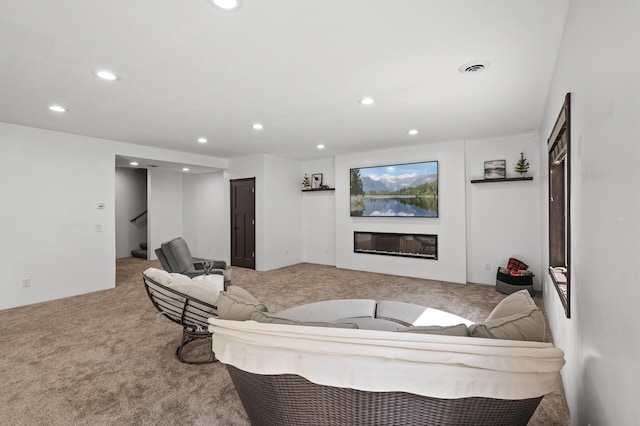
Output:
[[155, 237, 227, 278]]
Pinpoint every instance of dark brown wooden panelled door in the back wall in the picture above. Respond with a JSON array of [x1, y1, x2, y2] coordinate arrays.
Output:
[[231, 178, 256, 269]]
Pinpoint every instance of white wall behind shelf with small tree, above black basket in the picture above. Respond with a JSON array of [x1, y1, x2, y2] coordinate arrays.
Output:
[[465, 133, 542, 290]]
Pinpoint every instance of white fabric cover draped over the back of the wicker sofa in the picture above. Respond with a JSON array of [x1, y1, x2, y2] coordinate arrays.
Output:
[[209, 318, 564, 399]]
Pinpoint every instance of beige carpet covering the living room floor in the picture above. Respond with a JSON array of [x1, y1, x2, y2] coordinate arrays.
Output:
[[0, 258, 569, 425]]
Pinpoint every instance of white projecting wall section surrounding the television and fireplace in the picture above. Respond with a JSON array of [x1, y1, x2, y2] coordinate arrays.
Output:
[[335, 141, 467, 283]]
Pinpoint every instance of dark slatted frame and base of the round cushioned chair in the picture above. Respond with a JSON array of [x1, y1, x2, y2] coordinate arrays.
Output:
[[142, 274, 218, 365]]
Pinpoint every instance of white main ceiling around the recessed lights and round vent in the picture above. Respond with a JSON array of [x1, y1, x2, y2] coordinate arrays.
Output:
[[0, 0, 568, 159]]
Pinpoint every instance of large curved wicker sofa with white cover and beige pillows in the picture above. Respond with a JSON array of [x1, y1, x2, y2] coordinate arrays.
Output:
[[209, 287, 564, 426]]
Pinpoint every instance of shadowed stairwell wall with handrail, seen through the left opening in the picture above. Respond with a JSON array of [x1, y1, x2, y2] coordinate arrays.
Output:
[[115, 167, 147, 259]]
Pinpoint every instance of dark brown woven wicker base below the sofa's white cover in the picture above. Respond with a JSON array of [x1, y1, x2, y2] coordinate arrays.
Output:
[[227, 365, 542, 426]]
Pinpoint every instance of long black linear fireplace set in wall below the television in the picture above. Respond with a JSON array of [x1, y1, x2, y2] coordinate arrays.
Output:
[[353, 231, 438, 260]]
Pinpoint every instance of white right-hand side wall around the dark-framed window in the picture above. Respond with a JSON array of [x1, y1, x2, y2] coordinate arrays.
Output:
[[540, 1, 640, 425]]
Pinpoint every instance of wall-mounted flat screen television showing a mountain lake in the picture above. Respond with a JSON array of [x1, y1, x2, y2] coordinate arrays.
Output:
[[349, 161, 438, 217]]
